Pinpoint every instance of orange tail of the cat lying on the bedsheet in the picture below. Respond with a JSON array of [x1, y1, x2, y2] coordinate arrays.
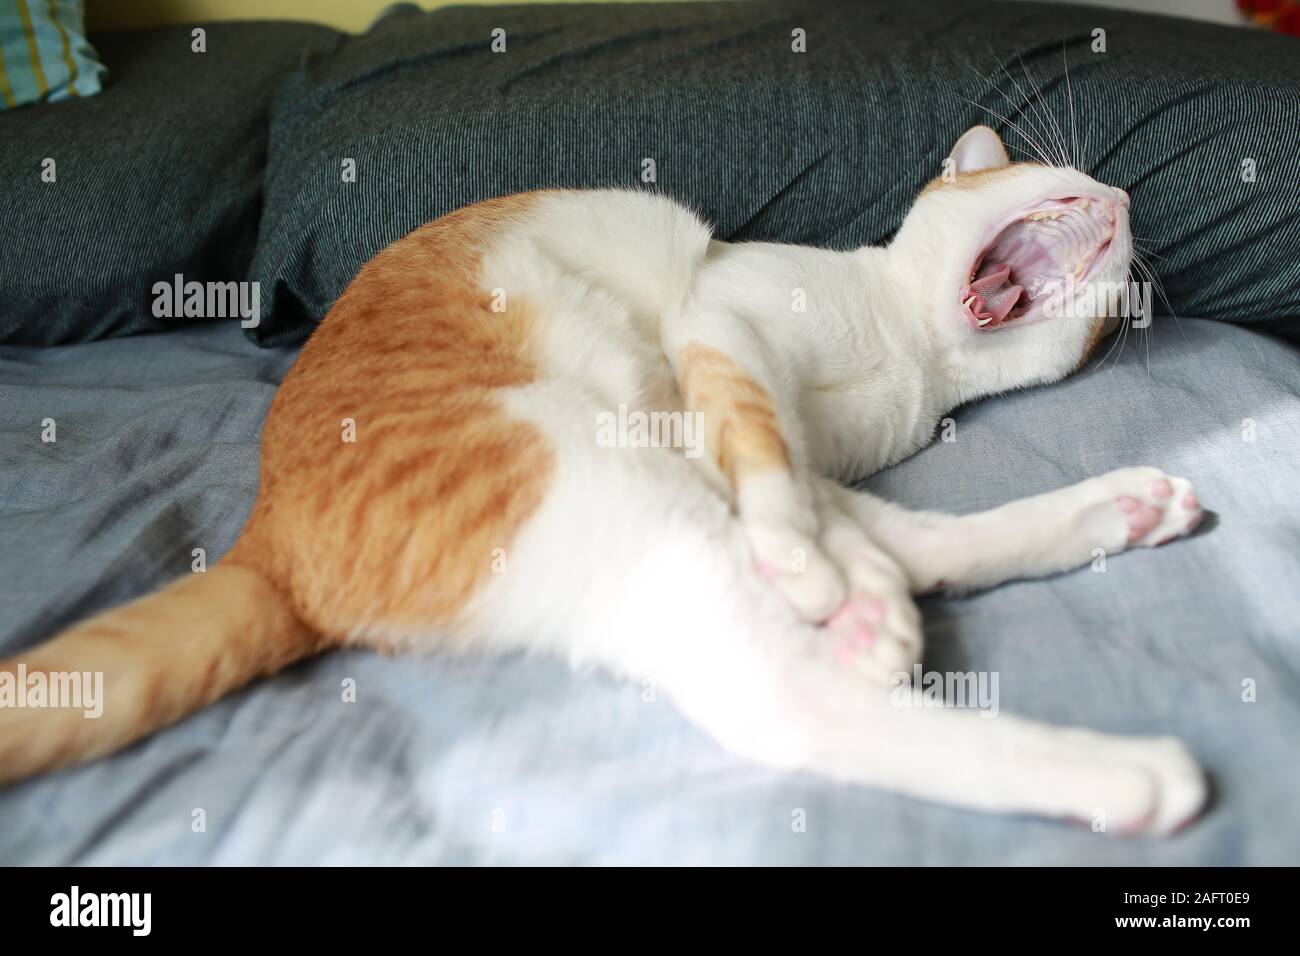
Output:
[[0, 561, 324, 784]]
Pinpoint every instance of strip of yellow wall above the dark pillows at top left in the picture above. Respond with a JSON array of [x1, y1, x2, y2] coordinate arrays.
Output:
[[86, 0, 655, 33]]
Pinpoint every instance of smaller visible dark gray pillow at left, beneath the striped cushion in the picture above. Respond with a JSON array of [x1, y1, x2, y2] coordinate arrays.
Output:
[[0, 23, 341, 345]]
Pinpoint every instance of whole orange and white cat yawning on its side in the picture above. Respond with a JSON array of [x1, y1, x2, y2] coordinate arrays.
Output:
[[0, 126, 1206, 832]]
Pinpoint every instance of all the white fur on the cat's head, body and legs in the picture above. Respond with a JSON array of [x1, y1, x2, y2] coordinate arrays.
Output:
[[452, 134, 1205, 832]]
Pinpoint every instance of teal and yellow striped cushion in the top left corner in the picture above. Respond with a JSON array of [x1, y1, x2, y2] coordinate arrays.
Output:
[[0, 0, 105, 109]]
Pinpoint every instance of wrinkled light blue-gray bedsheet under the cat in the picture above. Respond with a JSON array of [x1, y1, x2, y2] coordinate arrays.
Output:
[[0, 319, 1300, 865]]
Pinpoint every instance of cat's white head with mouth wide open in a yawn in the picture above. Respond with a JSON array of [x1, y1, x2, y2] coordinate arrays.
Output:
[[889, 126, 1132, 395]]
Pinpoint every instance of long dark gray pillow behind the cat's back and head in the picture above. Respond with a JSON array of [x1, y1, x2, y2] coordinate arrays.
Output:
[[250, 0, 1300, 343]]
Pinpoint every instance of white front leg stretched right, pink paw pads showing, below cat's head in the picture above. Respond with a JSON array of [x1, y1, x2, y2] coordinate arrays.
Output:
[[827, 467, 1203, 593]]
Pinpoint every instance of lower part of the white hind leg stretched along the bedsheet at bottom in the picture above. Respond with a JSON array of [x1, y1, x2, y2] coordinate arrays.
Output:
[[733, 660, 1206, 835]]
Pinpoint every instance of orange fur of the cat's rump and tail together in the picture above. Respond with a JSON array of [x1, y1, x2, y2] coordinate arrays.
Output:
[[0, 195, 553, 782]]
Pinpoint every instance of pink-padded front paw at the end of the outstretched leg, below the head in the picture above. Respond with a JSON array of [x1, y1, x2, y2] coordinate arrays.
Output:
[[1092, 468, 1205, 551]]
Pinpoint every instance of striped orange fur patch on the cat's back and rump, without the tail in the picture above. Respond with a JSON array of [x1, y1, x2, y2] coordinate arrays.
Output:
[[235, 196, 551, 639]]
